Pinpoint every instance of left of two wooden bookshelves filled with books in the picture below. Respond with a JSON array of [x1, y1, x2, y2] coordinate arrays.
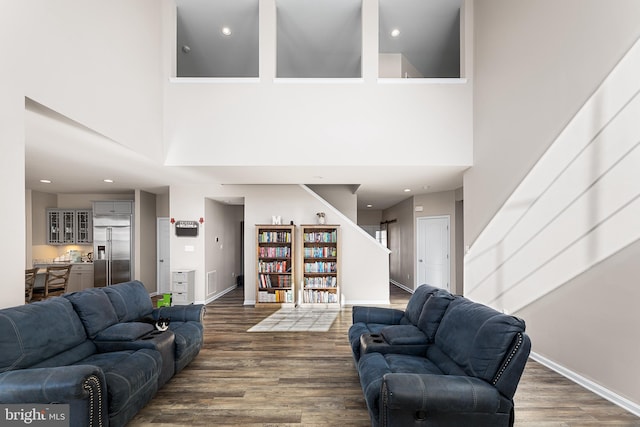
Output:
[[256, 225, 295, 305]]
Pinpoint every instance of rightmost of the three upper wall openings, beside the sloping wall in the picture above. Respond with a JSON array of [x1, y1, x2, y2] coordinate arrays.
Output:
[[378, 0, 462, 78]]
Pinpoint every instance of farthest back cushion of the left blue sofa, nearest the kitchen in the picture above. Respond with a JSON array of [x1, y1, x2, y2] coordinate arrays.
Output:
[[103, 280, 153, 322]]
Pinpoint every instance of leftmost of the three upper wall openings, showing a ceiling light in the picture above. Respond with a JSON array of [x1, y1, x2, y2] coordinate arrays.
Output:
[[176, 0, 259, 78]]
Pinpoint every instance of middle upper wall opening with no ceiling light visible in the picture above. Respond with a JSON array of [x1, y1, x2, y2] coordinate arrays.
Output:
[[276, 0, 362, 78]]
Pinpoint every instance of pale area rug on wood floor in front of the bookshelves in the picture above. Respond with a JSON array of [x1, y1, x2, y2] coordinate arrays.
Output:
[[247, 307, 340, 332]]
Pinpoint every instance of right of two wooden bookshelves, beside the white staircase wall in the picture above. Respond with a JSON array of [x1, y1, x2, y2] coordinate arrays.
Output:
[[299, 224, 340, 306]]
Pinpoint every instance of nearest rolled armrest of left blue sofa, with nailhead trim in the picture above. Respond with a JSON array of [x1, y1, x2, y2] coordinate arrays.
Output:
[[0, 365, 107, 406]]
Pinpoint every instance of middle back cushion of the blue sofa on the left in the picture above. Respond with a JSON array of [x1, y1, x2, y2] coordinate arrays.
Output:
[[64, 289, 118, 339]]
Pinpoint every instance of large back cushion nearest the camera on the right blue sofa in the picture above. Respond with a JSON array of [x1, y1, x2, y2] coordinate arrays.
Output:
[[428, 297, 525, 383]]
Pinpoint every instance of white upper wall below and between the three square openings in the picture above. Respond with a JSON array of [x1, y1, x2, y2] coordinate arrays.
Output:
[[165, 0, 473, 166]]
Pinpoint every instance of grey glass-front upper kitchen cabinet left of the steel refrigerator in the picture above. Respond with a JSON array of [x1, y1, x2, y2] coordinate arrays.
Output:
[[47, 208, 93, 245]]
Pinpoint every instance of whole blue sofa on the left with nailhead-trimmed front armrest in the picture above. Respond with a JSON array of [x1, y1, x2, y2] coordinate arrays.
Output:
[[0, 281, 204, 426]]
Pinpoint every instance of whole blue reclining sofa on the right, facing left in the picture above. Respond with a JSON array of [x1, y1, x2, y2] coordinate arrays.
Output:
[[349, 285, 531, 427]]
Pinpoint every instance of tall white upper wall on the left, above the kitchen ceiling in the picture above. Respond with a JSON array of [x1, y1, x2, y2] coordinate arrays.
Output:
[[23, 0, 168, 160]]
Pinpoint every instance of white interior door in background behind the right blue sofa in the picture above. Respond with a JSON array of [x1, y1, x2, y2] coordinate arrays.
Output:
[[416, 216, 451, 291]]
